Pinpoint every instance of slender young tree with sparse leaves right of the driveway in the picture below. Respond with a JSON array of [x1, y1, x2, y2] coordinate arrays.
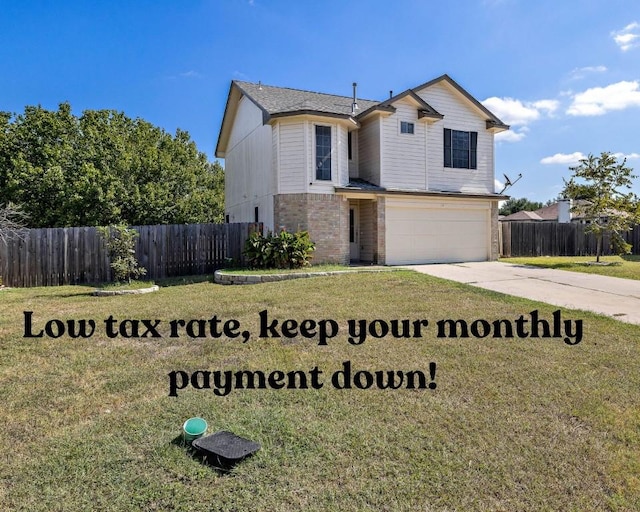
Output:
[[563, 152, 640, 262]]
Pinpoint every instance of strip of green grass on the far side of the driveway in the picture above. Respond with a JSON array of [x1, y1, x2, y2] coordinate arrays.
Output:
[[500, 255, 640, 279]]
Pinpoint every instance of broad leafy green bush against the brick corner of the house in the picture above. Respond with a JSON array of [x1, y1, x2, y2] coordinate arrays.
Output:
[[244, 230, 316, 268]]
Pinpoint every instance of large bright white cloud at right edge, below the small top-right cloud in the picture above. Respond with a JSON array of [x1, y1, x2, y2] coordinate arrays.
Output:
[[567, 80, 640, 116]]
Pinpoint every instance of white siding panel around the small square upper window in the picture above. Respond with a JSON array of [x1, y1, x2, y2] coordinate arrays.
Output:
[[380, 101, 427, 190]]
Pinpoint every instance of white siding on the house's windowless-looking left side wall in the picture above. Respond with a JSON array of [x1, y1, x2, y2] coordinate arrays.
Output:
[[225, 97, 274, 229]]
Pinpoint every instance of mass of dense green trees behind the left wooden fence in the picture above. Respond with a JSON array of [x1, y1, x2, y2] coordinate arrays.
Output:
[[0, 103, 224, 227]]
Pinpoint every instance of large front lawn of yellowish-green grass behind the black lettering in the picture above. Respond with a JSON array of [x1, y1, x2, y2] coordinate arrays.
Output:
[[0, 271, 640, 511]]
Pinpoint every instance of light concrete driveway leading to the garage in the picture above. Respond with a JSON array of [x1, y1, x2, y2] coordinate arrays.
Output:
[[405, 261, 640, 325]]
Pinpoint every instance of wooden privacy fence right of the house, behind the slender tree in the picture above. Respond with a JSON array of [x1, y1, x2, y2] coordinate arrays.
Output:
[[500, 222, 640, 257]]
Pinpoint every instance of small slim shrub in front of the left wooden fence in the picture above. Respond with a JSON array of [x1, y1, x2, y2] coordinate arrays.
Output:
[[98, 224, 147, 284]]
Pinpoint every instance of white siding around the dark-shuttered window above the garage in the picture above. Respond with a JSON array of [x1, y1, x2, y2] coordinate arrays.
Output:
[[417, 82, 494, 193]]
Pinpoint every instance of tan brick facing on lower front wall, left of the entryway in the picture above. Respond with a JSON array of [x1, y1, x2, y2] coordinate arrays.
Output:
[[273, 194, 349, 265]]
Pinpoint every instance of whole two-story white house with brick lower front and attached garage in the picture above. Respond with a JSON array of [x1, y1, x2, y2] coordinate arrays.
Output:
[[216, 75, 509, 265]]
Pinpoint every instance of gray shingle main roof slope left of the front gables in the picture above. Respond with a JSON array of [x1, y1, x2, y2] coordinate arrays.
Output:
[[234, 80, 380, 116]]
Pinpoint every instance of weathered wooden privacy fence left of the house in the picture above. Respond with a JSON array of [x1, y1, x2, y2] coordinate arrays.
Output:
[[0, 223, 262, 287]]
